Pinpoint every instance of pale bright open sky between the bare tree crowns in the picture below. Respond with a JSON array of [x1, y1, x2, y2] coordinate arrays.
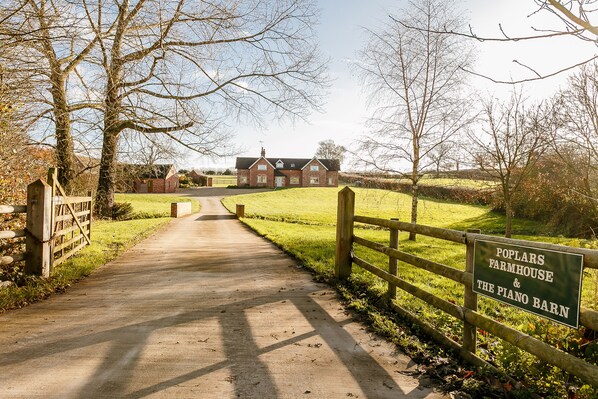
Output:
[[189, 0, 595, 170]]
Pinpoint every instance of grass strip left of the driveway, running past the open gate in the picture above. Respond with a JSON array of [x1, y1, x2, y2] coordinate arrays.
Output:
[[0, 194, 199, 312]]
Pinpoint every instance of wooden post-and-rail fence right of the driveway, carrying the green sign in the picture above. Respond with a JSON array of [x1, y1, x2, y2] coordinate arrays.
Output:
[[335, 187, 598, 386]]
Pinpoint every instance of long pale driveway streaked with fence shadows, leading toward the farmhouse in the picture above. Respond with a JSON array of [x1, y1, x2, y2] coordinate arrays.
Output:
[[0, 189, 442, 398]]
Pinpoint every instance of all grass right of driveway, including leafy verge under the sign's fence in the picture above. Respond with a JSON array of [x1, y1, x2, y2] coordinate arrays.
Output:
[[223, 188, 598, 398]]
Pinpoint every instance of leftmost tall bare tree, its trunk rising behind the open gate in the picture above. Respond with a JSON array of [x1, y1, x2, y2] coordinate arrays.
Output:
[[0, 0, 97, 187]]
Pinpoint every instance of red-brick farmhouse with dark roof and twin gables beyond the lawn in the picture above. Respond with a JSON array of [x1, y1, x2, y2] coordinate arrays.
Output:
[[235, 149, 340, 188]]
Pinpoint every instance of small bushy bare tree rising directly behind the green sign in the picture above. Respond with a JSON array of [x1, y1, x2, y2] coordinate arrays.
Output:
[[470, 92, 547, 237]]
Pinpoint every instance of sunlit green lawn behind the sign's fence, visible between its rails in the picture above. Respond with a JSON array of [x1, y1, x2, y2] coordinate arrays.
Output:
[[223, 188, 598, 397]]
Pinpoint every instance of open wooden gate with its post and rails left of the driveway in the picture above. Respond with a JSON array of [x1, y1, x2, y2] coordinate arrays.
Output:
[[0, 169, 92, 277]]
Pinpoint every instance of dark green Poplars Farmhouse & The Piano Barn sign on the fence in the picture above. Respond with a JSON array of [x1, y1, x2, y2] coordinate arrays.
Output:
[[473, 240, 583, 328]]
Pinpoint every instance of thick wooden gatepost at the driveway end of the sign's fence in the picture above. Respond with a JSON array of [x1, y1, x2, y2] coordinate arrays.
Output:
[[334, 187, 355, 279]]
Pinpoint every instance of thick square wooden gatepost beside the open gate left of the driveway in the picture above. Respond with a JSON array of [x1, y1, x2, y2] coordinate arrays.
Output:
[[25, 180, 52, 277]]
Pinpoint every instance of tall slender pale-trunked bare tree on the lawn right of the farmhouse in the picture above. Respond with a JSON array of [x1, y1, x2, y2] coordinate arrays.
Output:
[[358, 0, 472, 240]]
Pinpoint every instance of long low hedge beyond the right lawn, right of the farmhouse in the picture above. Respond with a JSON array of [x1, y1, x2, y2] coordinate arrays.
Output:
[[341, 174, 496, 205]]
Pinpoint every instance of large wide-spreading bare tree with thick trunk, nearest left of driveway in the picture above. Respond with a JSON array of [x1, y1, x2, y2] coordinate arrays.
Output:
[[84, 0, 326, 216]]
